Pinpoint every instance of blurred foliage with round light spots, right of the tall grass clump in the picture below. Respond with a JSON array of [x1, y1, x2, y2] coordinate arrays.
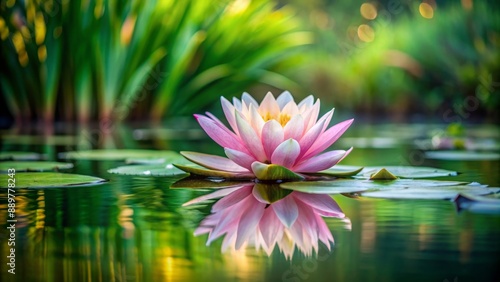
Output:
[[293, 0, 500, 120]]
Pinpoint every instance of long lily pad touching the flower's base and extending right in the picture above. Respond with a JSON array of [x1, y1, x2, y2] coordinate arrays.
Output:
[[280, 179, 467, 194]]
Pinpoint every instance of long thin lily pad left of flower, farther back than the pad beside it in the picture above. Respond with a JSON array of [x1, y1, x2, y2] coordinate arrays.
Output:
[[59, 149, 184, 162]]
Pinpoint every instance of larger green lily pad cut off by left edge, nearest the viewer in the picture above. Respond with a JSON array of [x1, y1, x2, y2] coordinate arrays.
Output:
[[0, 172, 106, 189]]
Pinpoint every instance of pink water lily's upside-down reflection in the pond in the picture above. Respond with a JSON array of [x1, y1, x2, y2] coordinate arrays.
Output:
[[184, 183, 345, 259]]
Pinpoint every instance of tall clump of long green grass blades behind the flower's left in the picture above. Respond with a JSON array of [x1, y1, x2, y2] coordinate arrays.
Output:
[[0, 0, 311, 121]]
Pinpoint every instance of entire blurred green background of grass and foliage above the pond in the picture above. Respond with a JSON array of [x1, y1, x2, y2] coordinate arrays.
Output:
[[0, 0, 500, 128]]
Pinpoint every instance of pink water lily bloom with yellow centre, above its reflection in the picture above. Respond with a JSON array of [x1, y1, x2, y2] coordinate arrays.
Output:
[[181, 91, 353, 180]]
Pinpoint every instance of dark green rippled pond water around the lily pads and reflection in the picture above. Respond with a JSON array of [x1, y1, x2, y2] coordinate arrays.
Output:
[[0, 124, 500, 282]]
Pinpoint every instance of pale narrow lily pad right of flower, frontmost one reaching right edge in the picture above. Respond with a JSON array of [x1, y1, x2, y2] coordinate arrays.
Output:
[[362, 185, 500, 199]]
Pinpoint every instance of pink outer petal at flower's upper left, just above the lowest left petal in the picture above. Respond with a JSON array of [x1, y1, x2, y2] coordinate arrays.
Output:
[[194, 115, 247, 152]]
